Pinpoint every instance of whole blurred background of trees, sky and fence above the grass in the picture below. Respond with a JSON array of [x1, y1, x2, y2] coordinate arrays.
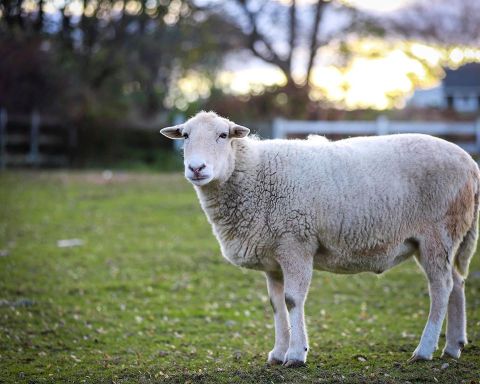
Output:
[[0, 0, 480, 170]]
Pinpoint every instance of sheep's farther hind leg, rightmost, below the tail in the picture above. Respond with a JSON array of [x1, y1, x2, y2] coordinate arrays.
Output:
[[443, 269, 467, 359]]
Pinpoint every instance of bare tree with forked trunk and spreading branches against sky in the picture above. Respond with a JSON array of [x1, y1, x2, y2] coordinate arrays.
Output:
[[218, 0, 362, 91]]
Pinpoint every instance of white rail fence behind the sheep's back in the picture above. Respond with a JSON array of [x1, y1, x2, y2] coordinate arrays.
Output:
[[272, 116, 480, 156]]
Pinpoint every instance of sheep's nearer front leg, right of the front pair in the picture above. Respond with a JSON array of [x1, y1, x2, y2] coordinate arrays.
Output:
[[281, 255, 313, 367]]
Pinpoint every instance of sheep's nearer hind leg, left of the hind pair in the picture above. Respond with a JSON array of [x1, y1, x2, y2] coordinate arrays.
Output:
[[409, 231, 453, 362]]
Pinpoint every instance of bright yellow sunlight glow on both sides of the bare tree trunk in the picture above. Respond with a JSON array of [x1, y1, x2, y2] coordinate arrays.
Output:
[[212, 39, 480, 109]]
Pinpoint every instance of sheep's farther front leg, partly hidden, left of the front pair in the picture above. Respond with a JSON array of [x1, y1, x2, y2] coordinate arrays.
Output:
[[265, 271, 290, 365]]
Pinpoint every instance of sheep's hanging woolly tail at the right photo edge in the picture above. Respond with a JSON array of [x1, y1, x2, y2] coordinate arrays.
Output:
[[455, 173, 480, 278]]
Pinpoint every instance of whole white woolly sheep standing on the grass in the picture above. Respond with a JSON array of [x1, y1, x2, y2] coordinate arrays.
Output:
[[161, 112, 480, 367]]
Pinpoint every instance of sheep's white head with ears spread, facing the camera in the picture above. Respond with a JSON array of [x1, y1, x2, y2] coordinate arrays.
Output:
[[160, 112, 250, 186]]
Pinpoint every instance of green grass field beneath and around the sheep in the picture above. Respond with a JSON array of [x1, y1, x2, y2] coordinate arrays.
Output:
[[0, 172, 480, 383]]
